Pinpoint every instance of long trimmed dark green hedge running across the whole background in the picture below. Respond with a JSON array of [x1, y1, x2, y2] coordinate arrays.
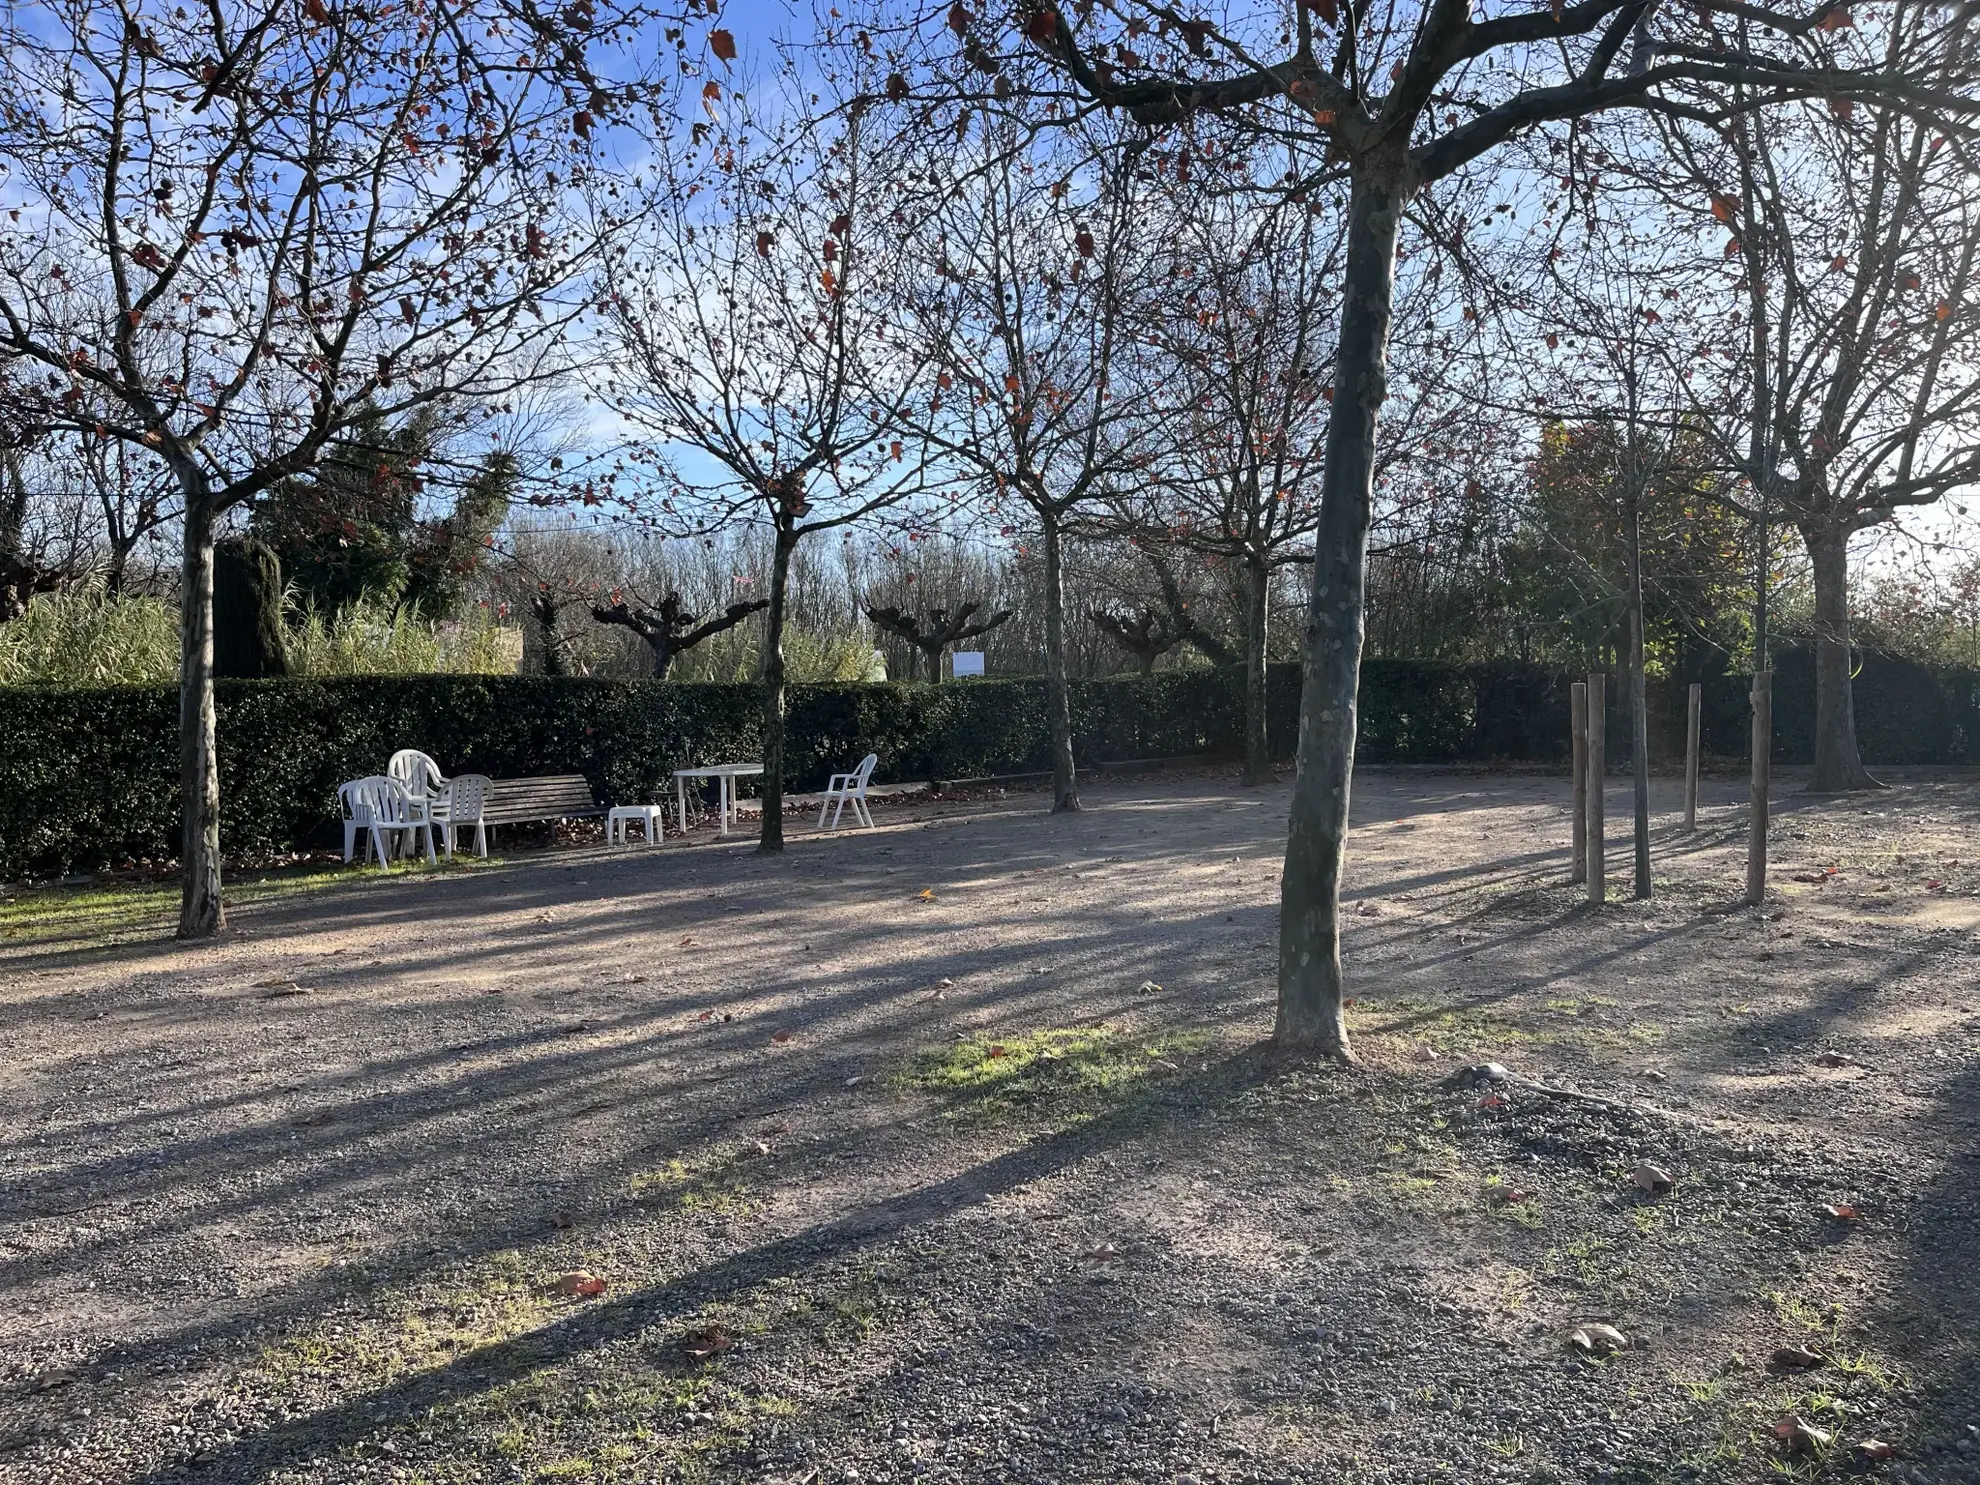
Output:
[[0, 655, 1980, 879]]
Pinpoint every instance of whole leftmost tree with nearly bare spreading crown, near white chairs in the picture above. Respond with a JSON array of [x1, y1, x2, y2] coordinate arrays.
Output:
[[0, 0, 642, 937]]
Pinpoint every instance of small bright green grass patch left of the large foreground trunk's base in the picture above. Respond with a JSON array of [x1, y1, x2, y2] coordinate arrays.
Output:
[[893, 1024, 1210, 1109]]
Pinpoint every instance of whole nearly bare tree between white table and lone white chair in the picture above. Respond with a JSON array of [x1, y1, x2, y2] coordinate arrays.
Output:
[[600, 77, 927, 851]]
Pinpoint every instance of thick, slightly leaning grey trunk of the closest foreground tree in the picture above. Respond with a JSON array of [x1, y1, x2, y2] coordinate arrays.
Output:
[[1273, 166, 1404, 1061]]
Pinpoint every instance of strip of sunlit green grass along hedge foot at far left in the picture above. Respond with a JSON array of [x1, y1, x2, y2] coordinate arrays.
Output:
[[0, 855, 493, 948]]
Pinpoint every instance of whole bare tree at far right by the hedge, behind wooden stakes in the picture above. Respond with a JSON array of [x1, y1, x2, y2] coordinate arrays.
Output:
[[1663, 34, 1980, 792]]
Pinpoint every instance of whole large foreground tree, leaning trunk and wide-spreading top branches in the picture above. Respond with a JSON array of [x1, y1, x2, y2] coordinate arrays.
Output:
[[897, 0, 1980, 1057]]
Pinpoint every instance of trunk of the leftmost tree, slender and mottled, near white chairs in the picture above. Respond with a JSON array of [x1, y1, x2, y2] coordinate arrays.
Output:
[[178, 491, 226, 939]]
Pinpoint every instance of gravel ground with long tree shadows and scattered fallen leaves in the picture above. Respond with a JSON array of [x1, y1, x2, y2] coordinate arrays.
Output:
[[0, 770, 1980, 1485]]
